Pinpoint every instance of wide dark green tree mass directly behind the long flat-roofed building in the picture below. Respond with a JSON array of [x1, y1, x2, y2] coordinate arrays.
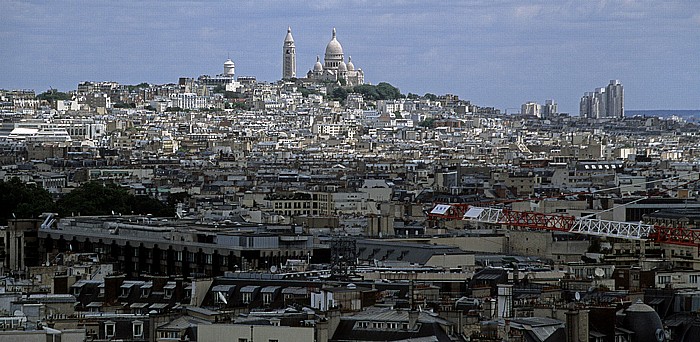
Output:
[[56, 182, 174, 216]]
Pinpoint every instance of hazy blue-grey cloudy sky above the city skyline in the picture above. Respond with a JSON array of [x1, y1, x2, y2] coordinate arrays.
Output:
[[0, 0, 700, 114]]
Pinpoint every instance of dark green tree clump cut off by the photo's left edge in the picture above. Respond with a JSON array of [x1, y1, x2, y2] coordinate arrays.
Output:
[[0, 177, 55, 225]]
